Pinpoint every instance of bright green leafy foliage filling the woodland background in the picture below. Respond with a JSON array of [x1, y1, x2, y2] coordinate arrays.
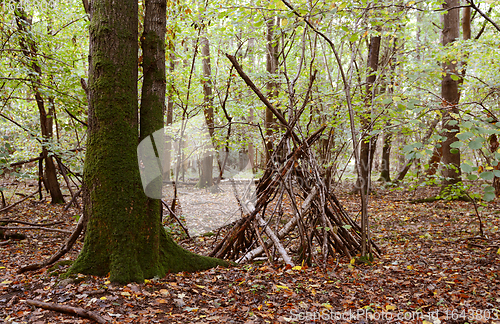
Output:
[[0, 0, 500, 204]]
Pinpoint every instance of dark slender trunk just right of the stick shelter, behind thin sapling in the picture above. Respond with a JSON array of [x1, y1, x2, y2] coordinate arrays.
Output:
[[356, 36, 381, 194]]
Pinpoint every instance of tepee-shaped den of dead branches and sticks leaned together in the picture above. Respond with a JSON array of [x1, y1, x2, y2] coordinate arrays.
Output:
[[210, 55, 380, 268]]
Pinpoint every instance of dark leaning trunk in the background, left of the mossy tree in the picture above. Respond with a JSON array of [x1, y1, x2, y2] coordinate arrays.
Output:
[[16, 5, 64, 204]]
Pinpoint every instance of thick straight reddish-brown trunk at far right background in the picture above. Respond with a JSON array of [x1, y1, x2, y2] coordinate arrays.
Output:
[[441, 0, 460, 188]]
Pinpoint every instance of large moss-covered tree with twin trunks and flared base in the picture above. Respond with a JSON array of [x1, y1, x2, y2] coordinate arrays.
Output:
[[69, 0, 227, 283]]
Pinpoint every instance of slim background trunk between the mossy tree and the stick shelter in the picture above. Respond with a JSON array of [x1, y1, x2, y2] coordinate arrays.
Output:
[[197, 37, 214, 188]]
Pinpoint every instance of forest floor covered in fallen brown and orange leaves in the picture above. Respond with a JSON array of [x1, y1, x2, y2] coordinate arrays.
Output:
[[0, 178, 500, 324]]
